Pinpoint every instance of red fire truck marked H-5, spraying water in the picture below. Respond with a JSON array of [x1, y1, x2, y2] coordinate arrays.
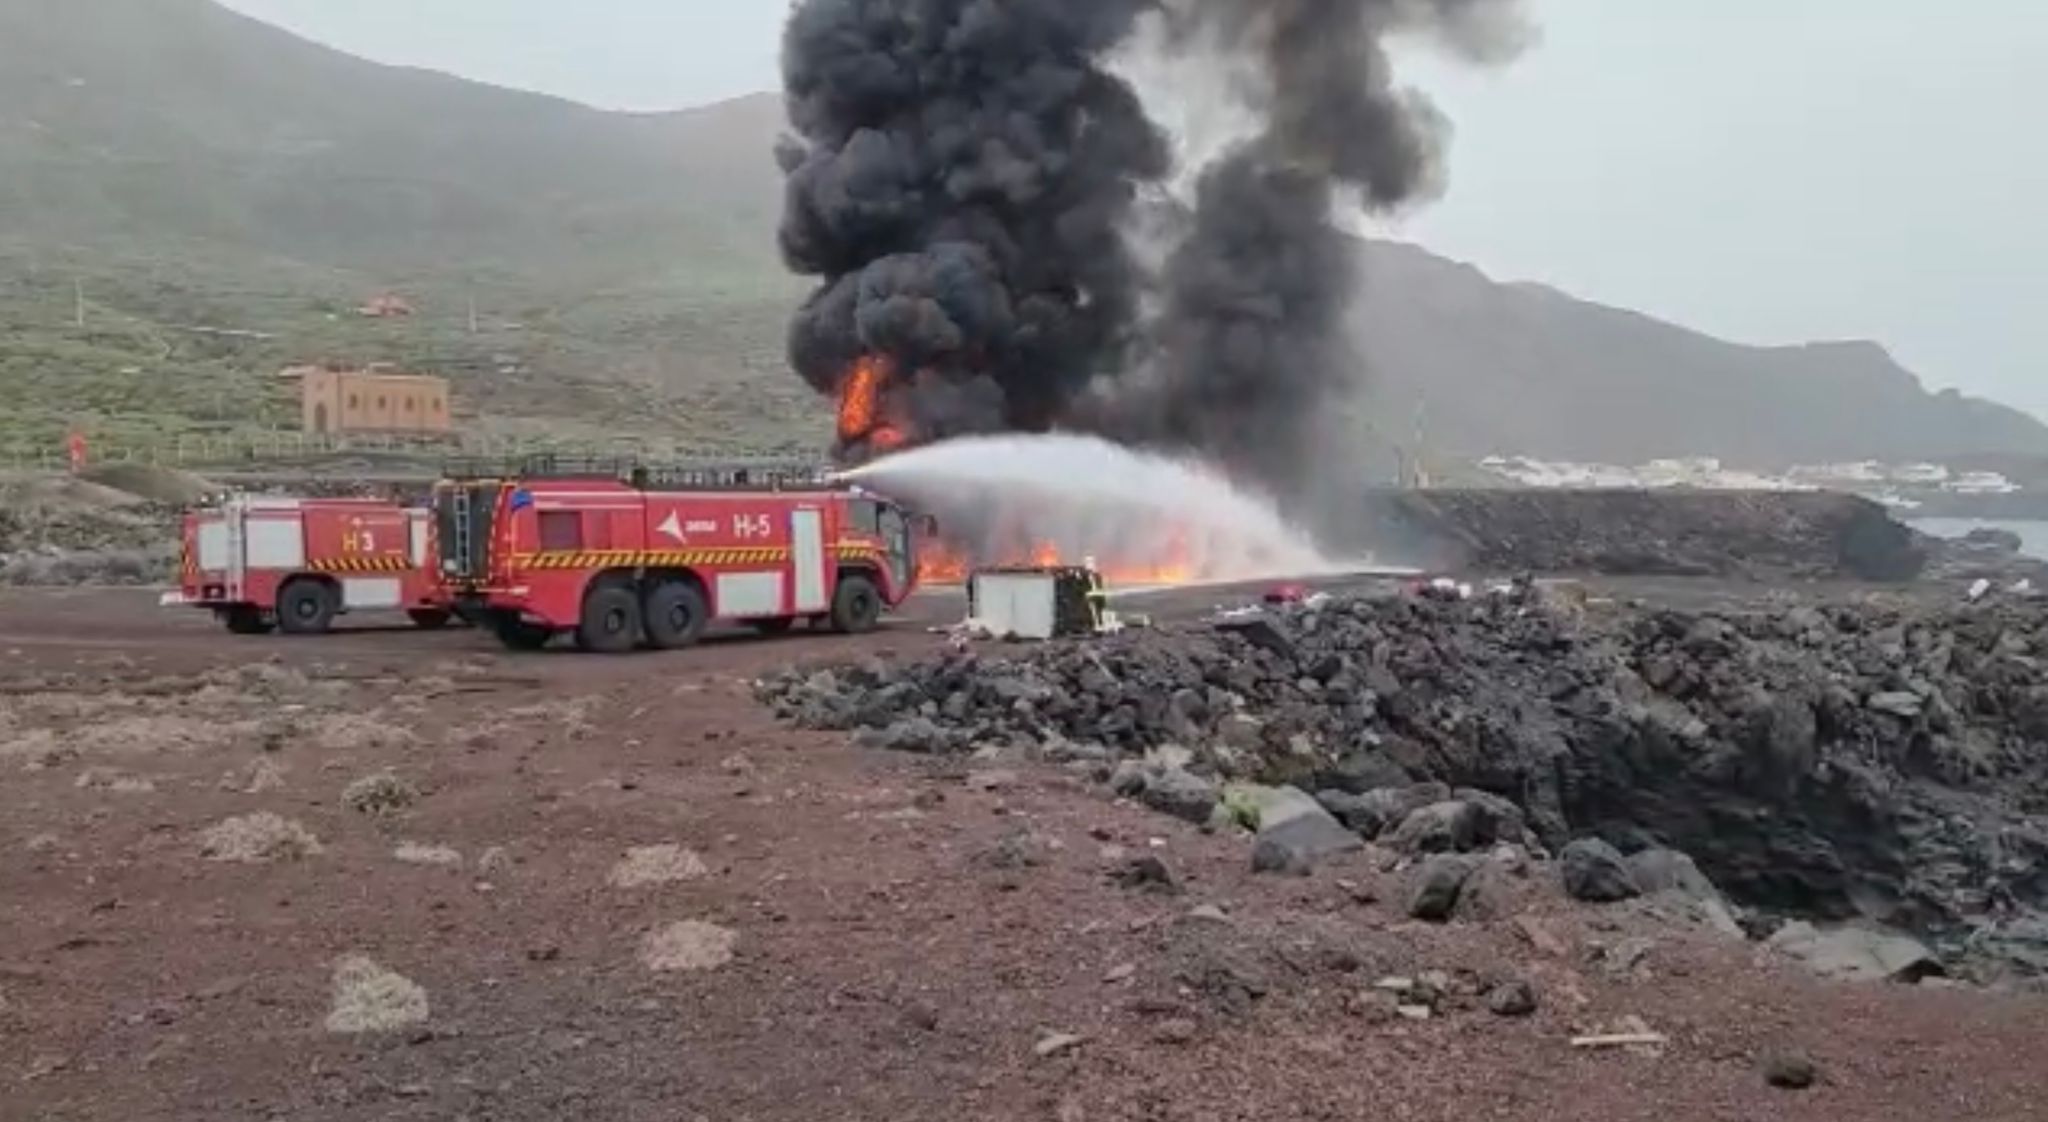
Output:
[[434, 459, 918, 653]]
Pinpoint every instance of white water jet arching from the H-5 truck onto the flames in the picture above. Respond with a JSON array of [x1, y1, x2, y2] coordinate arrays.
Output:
[[842, 434, 1356, 584]]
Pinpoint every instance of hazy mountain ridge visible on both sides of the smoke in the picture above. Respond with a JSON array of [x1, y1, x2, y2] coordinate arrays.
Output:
[[0, 0, 2048, 463]]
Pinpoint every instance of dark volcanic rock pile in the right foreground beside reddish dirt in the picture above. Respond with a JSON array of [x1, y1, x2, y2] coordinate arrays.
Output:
[[760, 588, 2048, 966]]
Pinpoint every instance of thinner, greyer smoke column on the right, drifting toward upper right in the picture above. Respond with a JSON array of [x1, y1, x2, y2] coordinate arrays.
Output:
[[1106, 0, 1520, 514]]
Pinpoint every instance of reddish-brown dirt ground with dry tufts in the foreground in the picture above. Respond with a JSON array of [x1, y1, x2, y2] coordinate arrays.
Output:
[[0, 590, 2048, 1122]]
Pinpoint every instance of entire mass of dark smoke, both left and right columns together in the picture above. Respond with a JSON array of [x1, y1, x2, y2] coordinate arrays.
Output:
[[780, 0, 1520, 500]]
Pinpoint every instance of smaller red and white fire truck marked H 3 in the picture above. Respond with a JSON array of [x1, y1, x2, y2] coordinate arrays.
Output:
[[164, 495, 453, 635]]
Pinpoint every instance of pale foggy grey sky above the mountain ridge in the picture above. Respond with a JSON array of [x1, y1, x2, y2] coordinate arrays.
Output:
[[227, 0, 2048, 416]]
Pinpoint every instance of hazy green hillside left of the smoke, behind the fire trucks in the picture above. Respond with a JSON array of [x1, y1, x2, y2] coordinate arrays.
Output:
[[0, 0, 821, 460]]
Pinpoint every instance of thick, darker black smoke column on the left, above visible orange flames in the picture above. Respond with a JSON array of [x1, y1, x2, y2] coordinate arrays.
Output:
[[778, 0, 1167, 459]]
